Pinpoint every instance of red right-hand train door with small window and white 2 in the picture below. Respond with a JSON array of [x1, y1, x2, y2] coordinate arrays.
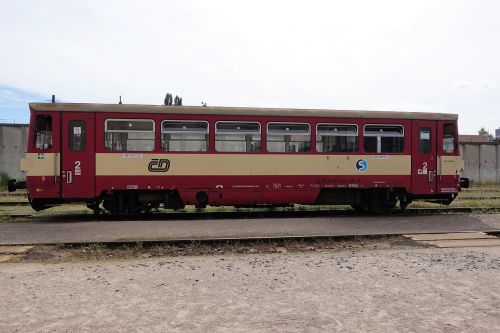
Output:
[[411, 120, 437, 194]]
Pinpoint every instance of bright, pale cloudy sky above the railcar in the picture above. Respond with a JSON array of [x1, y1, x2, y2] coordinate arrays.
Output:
[[0, 0, 500, 134]]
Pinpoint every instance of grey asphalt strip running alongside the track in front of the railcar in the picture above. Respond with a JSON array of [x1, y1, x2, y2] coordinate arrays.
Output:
[[0, 214, 500, 245]]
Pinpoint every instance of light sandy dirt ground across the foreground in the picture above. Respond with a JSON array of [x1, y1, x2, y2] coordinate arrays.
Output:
[[0, 244, 500, 332]]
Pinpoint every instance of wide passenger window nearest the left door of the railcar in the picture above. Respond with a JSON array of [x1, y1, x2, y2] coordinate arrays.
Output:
[[104, 119, 155, 151]]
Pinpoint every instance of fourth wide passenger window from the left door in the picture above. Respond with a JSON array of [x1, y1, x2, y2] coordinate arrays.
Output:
[[267, 123, 311, 153]]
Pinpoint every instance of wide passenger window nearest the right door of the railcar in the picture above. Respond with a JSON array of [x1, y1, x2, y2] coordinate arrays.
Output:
[[364, 125, 404, 154]]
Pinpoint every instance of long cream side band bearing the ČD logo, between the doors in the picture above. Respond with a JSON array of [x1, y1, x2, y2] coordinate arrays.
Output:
[[96, 153, 411, 176]]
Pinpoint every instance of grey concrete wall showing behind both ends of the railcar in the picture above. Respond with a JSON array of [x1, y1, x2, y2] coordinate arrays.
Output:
[[0, 124, 500, 184]]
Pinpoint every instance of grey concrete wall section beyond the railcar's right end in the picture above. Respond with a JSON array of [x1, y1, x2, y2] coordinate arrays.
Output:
[[460, 142, 500, 184]]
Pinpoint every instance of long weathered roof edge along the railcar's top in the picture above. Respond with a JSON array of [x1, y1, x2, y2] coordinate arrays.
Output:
[[29, 103, 458, 120]]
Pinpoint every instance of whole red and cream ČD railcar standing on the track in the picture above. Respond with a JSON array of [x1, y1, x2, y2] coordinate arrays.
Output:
[[10, 103, 465, 214]]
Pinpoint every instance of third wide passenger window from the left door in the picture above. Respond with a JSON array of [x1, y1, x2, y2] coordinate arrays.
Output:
[[215, 121, 261, 153]]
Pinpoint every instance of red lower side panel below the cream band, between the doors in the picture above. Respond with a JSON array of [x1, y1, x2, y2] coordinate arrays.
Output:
[[96, 176, 411, 205]]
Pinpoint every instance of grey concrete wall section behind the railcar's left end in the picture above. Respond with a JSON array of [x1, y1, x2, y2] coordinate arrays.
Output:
[[0, 124, 28, 180]]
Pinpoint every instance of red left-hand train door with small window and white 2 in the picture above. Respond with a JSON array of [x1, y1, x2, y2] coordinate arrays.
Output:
[[61, 112, 95, 199]]
